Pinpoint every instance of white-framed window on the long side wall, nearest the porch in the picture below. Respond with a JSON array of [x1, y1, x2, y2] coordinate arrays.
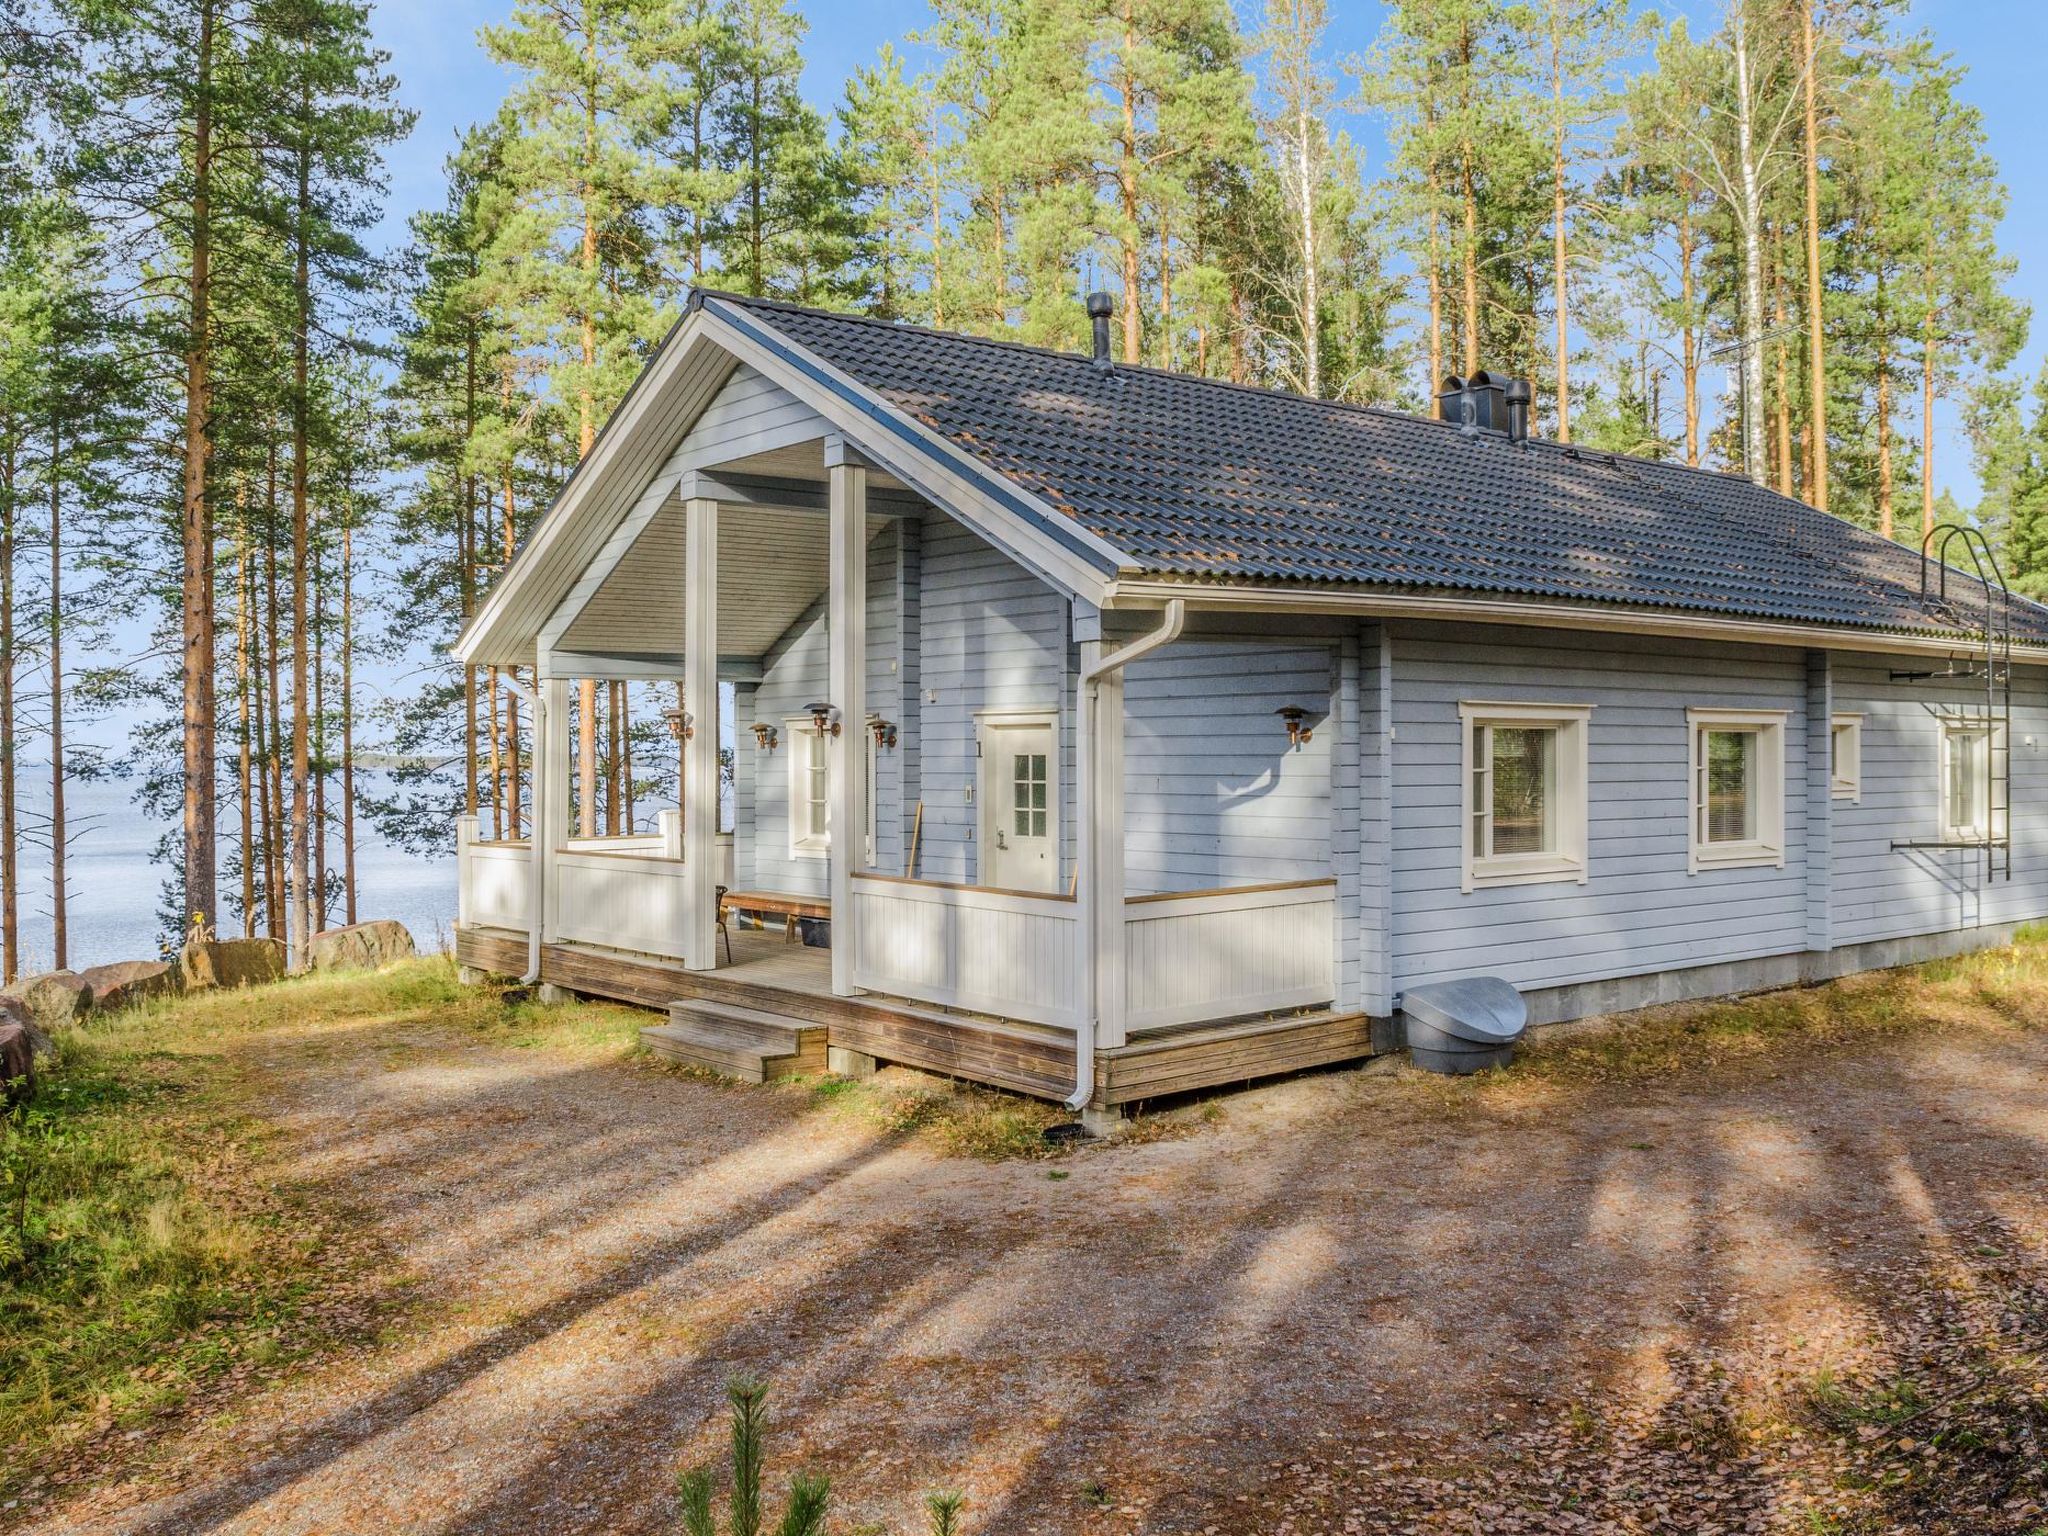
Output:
[[1458, 702, 1591, 891]]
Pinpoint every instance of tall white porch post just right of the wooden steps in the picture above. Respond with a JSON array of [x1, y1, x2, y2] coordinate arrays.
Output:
[[825, 438, 868, 997]]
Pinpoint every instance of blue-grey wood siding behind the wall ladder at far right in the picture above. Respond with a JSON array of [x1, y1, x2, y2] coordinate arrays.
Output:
[[1833, 655, 2048, 944]]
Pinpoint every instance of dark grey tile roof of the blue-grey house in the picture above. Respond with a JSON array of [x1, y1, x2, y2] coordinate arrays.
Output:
[[707, 295, 2048, 643]]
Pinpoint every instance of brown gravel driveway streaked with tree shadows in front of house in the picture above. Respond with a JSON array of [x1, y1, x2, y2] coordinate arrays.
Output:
[[19, 987, 2048, 1536]]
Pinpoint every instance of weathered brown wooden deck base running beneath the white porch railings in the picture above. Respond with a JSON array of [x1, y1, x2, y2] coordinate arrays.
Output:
[[455, 928, 1372, 1108]]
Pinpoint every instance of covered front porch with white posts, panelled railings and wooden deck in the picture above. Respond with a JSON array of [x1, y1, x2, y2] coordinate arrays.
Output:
[[457, 339, 1370, 1108]]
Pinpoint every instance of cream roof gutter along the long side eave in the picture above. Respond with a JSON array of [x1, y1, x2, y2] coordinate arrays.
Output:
[[1106, 580, 2048, 666]]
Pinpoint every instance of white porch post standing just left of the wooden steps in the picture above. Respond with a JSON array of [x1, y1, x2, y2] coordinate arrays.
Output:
[[682, 498, 719, 971]]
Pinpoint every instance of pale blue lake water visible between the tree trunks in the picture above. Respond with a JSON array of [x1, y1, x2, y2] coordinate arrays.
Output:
[[7, 764, 455, 973]]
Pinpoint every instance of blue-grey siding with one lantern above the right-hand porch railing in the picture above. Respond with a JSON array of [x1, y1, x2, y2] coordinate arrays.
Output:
[[1124, 639, 1339, 895]]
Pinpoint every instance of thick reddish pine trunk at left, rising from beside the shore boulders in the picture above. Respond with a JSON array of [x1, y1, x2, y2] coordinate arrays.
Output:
[[178, 0, 219, 932]]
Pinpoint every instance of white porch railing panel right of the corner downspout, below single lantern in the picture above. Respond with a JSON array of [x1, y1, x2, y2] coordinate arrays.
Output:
[[1124, 881, 1337, 1030]]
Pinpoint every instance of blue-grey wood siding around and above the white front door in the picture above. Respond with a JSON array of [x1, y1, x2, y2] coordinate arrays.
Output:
[[918, 512, 1073, 889]]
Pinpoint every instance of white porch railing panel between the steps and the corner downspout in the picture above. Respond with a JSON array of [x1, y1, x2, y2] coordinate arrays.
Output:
[[854, 874, 1081, 1026]]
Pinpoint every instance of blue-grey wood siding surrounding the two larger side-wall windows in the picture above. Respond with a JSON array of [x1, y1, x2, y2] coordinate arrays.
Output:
[[1389, 625, 1806, 987]]
